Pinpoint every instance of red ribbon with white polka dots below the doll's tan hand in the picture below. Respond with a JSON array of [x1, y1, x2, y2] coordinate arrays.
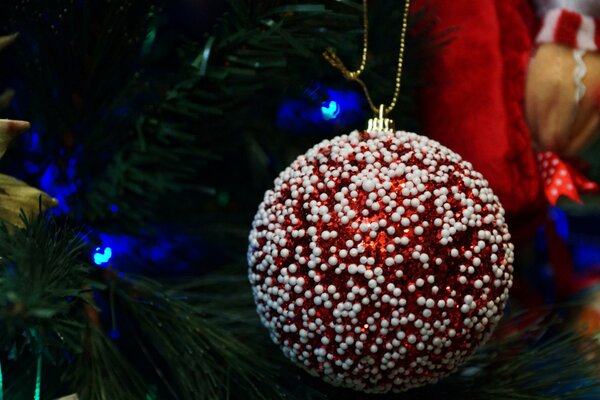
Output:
[[537, 151, 598, 205]]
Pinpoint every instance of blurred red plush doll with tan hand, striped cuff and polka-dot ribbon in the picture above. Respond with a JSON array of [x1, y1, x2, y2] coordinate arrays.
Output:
[[415, 0, 600, 242]]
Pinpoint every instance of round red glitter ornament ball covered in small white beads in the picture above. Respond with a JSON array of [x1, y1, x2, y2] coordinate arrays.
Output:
[[248, 131, 513, 393]]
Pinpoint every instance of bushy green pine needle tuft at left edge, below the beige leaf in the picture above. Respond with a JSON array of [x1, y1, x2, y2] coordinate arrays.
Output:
[[0, 216, 90, 356]]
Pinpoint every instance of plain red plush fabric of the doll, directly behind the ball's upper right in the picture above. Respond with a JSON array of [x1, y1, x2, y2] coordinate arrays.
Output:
[[414, 0, 545, 242]]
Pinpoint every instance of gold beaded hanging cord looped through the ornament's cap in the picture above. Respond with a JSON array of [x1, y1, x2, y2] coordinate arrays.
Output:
[[323, 0, 410, 119]]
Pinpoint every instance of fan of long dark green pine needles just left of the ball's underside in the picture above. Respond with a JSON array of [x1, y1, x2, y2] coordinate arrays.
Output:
[[114, 277, 277, 400]]
